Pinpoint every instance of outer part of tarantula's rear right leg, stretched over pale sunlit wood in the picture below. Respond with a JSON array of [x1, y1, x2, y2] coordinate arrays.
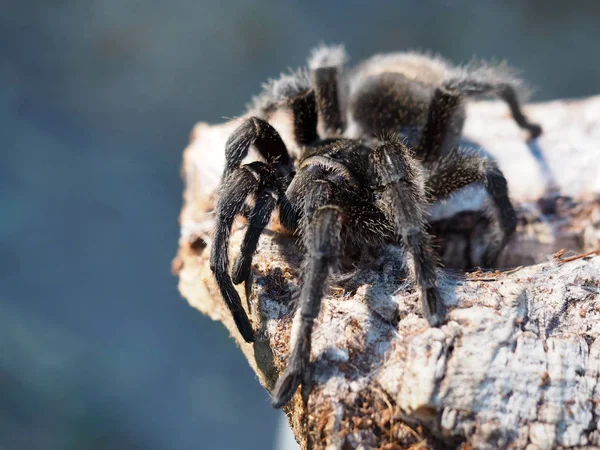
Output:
[[444, 73, 542, 139]]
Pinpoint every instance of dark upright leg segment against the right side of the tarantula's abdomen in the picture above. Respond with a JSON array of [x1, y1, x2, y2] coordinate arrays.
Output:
[[416, 87, 460, 163]]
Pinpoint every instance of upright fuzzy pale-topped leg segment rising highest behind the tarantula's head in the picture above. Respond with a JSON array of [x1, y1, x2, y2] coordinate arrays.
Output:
[[308, 45, 346, 136]]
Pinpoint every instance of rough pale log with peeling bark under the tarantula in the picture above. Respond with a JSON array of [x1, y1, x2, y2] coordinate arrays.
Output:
[[173, 97, 600, 450]]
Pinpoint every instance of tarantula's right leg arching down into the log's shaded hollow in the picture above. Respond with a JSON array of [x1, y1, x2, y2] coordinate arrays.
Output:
[[427, 148, 517, 267]]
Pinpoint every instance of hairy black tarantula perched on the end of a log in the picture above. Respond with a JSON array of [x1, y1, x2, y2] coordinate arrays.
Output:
[[210, 47, 535, 408]]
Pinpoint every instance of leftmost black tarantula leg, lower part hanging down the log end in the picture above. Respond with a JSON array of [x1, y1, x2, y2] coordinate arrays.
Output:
[[210, 166, 259, 342]]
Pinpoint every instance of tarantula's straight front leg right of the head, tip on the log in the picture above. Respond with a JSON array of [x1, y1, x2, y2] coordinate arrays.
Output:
[[372, 140, 442, 326]]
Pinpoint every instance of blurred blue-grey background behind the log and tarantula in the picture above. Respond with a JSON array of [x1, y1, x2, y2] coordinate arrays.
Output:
[[0, 0, 600, 450]]
